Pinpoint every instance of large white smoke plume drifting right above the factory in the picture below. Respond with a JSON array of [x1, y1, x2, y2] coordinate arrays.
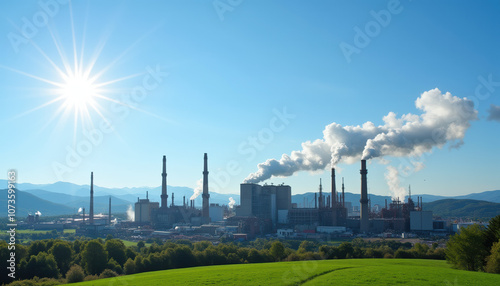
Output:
[[245, 88, 477, 183]]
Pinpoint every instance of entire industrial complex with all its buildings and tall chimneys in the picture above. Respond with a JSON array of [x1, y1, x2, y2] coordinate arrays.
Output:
[[21, 153, 462, 240]]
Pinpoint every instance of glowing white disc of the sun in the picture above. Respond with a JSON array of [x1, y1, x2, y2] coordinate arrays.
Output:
[[61, 74, 98, 111]]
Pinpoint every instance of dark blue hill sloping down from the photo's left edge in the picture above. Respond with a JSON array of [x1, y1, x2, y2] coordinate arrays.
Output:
[[0, 189, 74, 216]]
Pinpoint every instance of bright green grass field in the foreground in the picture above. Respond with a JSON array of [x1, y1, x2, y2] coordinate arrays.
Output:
[[72, 259, 500, 286]]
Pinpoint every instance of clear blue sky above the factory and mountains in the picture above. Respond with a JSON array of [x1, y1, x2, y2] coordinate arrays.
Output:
[[0, 0, 500, 195]]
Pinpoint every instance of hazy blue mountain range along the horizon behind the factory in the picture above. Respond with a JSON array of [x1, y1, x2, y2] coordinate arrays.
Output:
[[0, 180, 500, 219]]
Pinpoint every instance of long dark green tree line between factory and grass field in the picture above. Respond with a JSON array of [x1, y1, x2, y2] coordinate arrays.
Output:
[[0, 236, 445, 285]]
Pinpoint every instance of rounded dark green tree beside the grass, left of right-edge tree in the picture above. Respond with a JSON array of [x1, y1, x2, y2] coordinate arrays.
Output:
[[446, 224, 488, 271]]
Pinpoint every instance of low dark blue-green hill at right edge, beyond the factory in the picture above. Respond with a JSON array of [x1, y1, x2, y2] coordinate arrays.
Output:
[[424, 199, 500, 219]]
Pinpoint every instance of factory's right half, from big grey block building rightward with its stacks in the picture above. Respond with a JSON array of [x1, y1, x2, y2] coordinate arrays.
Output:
[[235, 160, 433, 233]]
